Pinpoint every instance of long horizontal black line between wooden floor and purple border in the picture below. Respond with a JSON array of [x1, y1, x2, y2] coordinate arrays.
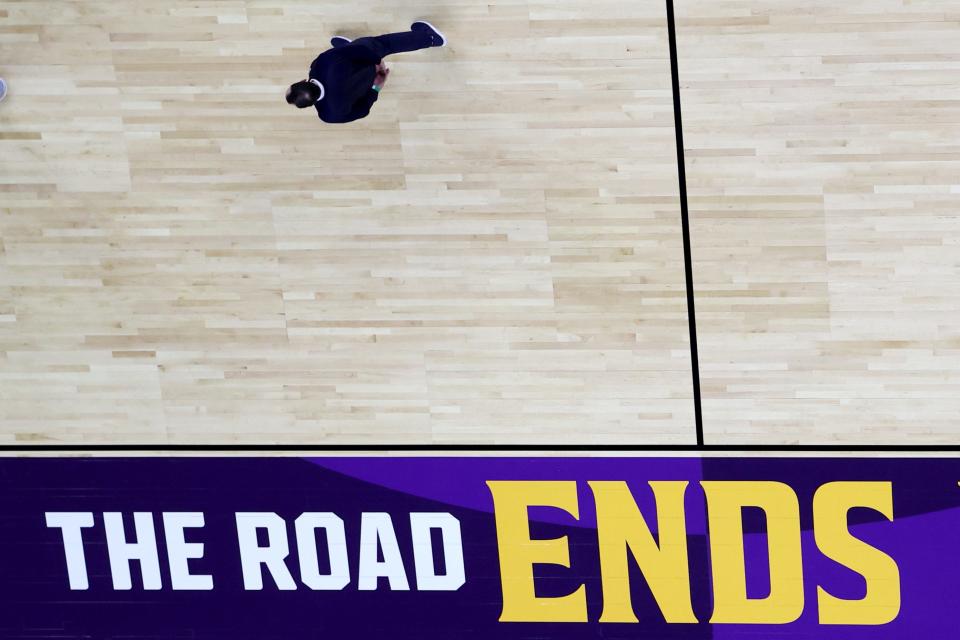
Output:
[[0, 444, 960, 454]]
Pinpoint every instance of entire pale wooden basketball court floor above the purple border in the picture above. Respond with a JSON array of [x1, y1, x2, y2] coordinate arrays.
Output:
[[0, 0, 960, 445]]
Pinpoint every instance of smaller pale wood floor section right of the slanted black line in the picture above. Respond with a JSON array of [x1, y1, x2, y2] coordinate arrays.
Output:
[[676, 0, 960, 444]]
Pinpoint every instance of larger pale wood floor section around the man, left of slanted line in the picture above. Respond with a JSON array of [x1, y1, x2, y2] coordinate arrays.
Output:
[[0, 0, 693, 444]]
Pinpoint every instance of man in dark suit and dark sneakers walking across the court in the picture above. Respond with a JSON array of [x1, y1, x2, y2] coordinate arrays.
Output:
[[287, 21, 447, 123]]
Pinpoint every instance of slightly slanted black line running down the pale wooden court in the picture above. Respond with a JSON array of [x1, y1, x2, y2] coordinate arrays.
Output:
[[666, 0, 704, 447]]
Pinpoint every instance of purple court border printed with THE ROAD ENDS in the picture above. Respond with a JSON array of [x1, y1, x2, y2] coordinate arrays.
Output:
[[0, 457, 960, 640]]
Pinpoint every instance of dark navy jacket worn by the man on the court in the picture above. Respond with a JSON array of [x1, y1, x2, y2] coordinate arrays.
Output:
[[310, 44, 381, 123]]
